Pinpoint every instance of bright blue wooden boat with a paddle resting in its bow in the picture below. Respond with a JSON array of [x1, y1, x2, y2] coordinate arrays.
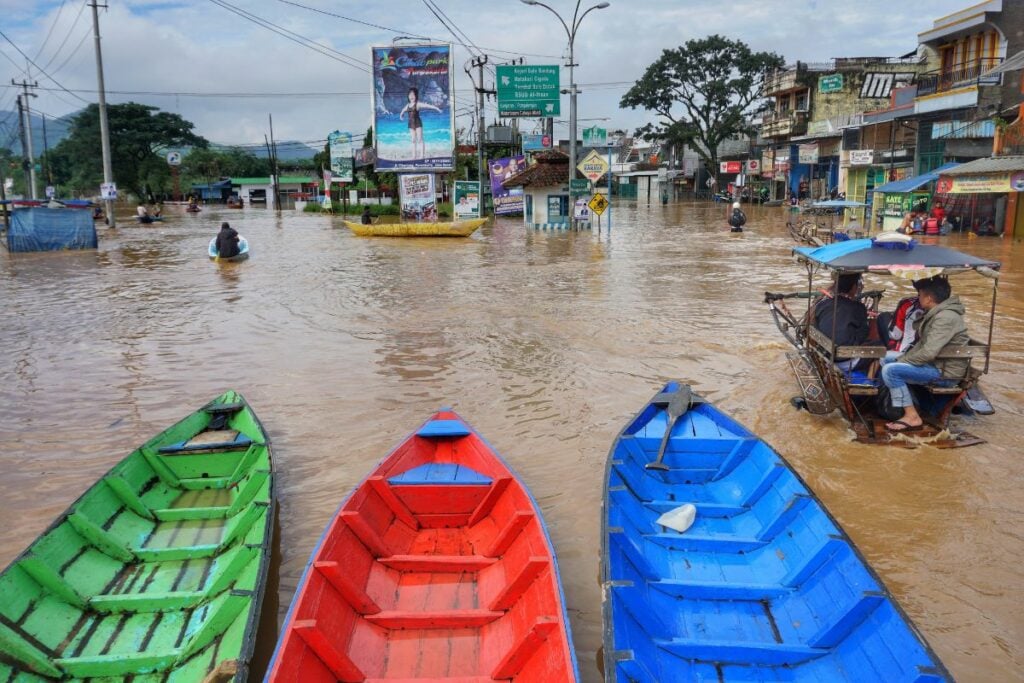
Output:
[[601, 382, 952, 683]]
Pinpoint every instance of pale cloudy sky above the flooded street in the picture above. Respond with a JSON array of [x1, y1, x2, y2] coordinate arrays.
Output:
[[0, 0, 971, 149]]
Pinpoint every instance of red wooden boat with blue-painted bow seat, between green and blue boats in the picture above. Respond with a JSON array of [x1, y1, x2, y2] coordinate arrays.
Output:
[[267, 410, 579, 683]]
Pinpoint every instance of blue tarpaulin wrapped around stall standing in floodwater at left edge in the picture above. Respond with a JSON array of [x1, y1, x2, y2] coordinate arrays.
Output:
[[7, 208, 96, 252]]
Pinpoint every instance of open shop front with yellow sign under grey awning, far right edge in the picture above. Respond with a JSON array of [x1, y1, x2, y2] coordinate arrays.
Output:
[[936, 156, 1024, 240]]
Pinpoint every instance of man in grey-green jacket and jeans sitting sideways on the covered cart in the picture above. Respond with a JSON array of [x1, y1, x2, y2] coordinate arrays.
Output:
[[882, 275, 970, 431]]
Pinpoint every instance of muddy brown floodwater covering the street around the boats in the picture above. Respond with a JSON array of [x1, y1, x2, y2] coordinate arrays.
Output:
[[0, 204, 1024, 681]]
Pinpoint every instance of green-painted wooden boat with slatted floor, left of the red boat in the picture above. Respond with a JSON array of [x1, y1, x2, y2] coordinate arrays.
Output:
[[0, 391, 274, 683]]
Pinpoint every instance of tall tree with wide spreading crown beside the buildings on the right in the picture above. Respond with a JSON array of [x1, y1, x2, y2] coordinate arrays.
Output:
[[620, 35, 785, 181]]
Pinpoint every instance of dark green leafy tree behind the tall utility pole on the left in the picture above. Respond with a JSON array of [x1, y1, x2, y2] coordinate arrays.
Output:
[[51, 102, 207, 198]]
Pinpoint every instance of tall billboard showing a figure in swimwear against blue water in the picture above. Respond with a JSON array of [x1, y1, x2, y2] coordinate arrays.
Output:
[[371, 44, 455, 171]]
